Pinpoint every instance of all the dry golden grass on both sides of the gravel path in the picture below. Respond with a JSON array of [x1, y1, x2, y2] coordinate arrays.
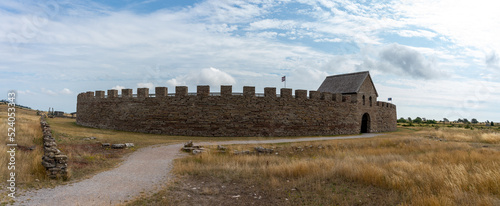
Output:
[[0, 105, 500, 205]]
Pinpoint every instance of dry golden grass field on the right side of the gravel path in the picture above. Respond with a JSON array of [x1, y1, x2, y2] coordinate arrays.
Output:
[[131, 127, 500, 205]]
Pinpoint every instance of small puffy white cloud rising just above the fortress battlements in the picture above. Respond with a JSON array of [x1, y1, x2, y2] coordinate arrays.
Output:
[[166, 67, 236, 88]]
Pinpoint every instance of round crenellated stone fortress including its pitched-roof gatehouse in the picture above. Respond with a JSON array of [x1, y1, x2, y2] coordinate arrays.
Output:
[[76, 72, 396, 136]]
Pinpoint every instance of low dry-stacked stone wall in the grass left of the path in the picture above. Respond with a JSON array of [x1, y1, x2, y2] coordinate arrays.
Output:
[[40, 116, 68, 179]]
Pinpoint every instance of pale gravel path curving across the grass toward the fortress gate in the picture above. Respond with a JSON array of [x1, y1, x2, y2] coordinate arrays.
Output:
[[14, 133, 380, 206]]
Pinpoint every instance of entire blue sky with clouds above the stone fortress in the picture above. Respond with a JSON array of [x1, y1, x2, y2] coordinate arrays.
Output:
[[0, 0, 500, 121]]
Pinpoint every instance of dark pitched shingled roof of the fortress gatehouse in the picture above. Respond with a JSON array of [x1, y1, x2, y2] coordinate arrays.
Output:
[[318, 71, 378, 96]]
